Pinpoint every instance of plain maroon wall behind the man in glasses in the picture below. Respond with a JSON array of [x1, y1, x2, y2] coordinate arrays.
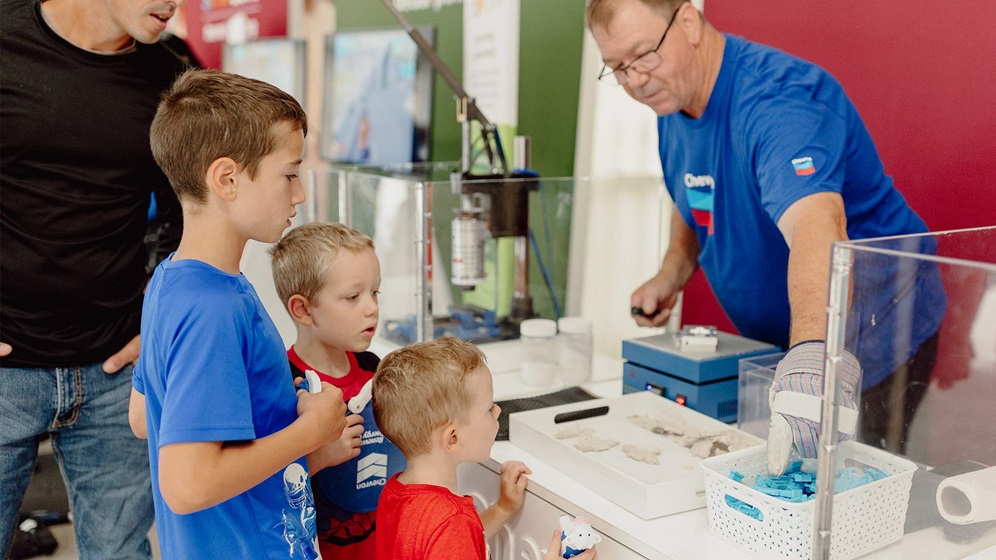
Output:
[[682, 0, 996, 336]]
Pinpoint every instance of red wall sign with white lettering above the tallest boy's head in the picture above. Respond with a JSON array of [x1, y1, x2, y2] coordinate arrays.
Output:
[[183, 0, 287, 69]]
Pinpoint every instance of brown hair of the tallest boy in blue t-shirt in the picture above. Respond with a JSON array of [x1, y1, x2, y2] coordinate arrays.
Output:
[[149, 70, 308, 204]]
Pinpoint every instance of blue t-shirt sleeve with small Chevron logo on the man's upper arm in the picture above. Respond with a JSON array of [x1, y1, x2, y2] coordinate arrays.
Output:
[[745, 88, 847, 224]]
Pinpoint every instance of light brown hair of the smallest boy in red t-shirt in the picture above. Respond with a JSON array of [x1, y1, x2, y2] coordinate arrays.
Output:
[[373, 337, 485, 459]]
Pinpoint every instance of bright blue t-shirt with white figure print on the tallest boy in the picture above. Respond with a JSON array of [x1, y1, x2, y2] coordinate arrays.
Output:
[[132, 255, 318, 560]]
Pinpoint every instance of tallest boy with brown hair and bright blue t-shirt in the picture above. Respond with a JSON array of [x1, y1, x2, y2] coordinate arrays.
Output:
[[129, 71, 345, 560]]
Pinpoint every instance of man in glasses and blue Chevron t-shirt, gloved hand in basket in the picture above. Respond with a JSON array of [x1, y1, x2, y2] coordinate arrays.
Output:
[[586, 0, 945, 472]]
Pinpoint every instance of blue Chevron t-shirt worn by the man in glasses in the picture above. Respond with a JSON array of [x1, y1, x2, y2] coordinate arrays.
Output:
[[658, 35, 944, 388]]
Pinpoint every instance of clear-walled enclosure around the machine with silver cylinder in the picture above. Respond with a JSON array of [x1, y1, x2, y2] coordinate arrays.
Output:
[[310, 162, 576, 345]]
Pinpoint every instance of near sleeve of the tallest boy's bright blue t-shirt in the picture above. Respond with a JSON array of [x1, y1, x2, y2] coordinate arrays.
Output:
[[159, 295, 256, 447]]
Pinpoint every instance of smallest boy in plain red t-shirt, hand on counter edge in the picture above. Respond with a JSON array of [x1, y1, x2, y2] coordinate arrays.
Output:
[[373, 338, 597, 560]]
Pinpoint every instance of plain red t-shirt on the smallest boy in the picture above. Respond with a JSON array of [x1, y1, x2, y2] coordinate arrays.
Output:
[[375, 476, 488, 560]]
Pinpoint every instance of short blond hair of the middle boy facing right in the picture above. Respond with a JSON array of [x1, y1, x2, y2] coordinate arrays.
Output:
[[270, 222, 374, 307]]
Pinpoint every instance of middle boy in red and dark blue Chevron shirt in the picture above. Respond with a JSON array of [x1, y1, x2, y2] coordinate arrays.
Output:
[[270, 223, 405, 560]]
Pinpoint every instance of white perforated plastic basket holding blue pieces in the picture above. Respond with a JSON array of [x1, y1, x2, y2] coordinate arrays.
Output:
[[702, 441, 916, 560]]
